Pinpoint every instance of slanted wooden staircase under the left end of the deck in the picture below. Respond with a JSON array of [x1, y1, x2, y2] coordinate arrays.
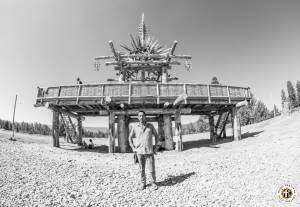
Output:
[[60, 113, 79, 144]]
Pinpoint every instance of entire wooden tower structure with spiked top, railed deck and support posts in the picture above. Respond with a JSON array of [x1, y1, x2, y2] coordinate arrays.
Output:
[[35, 15, 251, 153]]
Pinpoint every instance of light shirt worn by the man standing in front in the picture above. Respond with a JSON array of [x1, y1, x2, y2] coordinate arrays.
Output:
[[130, 123, 158, 154]]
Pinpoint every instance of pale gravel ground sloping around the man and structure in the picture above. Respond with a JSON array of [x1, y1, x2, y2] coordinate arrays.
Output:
[[0, 113, 300, 207]]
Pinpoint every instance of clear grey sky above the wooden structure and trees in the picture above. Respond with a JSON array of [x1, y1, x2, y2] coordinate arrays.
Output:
[[0, 0, 300, 126]]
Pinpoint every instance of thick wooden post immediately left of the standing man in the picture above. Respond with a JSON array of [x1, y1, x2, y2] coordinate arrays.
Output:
[[118, 115, 129, 153]]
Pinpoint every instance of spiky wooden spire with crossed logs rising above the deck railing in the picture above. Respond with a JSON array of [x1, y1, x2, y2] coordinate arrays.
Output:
[[95, 13, 192, 82]]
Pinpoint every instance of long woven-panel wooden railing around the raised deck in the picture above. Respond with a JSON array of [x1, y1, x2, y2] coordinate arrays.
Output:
[[37, 83, 250, 104]]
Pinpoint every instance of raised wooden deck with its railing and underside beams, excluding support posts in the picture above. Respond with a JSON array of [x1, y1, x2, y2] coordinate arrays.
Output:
[[35, 83, 250, 116]]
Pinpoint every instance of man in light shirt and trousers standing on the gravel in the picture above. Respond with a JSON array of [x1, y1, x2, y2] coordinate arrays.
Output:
[[129, 111, 161, 190]]
